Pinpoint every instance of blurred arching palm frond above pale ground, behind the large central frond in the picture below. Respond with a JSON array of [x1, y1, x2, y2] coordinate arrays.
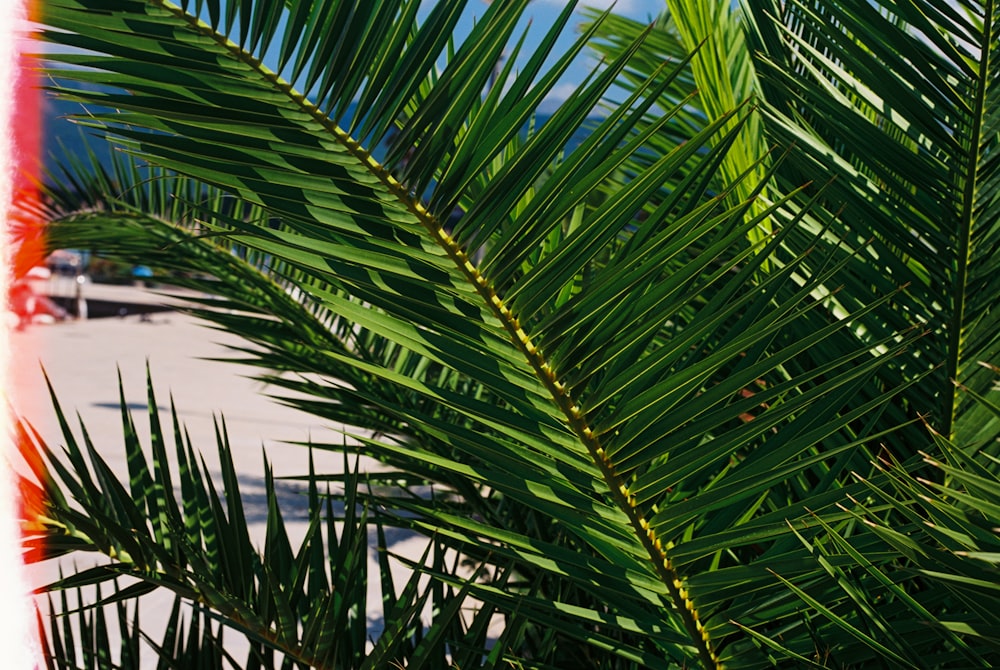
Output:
[[41, 154, 446, 444]]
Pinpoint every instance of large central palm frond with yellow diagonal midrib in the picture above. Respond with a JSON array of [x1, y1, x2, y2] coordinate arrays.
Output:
[[23, 0, 948, 667]]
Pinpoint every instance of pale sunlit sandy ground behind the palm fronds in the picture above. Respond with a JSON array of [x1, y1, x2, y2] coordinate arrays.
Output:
[[7, 289, 438, 667]]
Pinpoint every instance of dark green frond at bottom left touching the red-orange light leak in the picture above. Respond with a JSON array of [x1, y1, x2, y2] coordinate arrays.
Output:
[[18, 376, 491, 668]]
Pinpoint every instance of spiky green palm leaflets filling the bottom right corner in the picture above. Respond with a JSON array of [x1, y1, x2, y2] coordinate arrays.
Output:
[[750, 366, 1000, 668]]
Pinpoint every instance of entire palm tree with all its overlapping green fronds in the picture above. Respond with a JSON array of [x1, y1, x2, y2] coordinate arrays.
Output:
[[15, 0, 1000, 668]]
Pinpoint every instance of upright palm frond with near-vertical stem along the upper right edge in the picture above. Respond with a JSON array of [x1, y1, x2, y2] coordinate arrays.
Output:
[[746, 0, 1000, 447]]
